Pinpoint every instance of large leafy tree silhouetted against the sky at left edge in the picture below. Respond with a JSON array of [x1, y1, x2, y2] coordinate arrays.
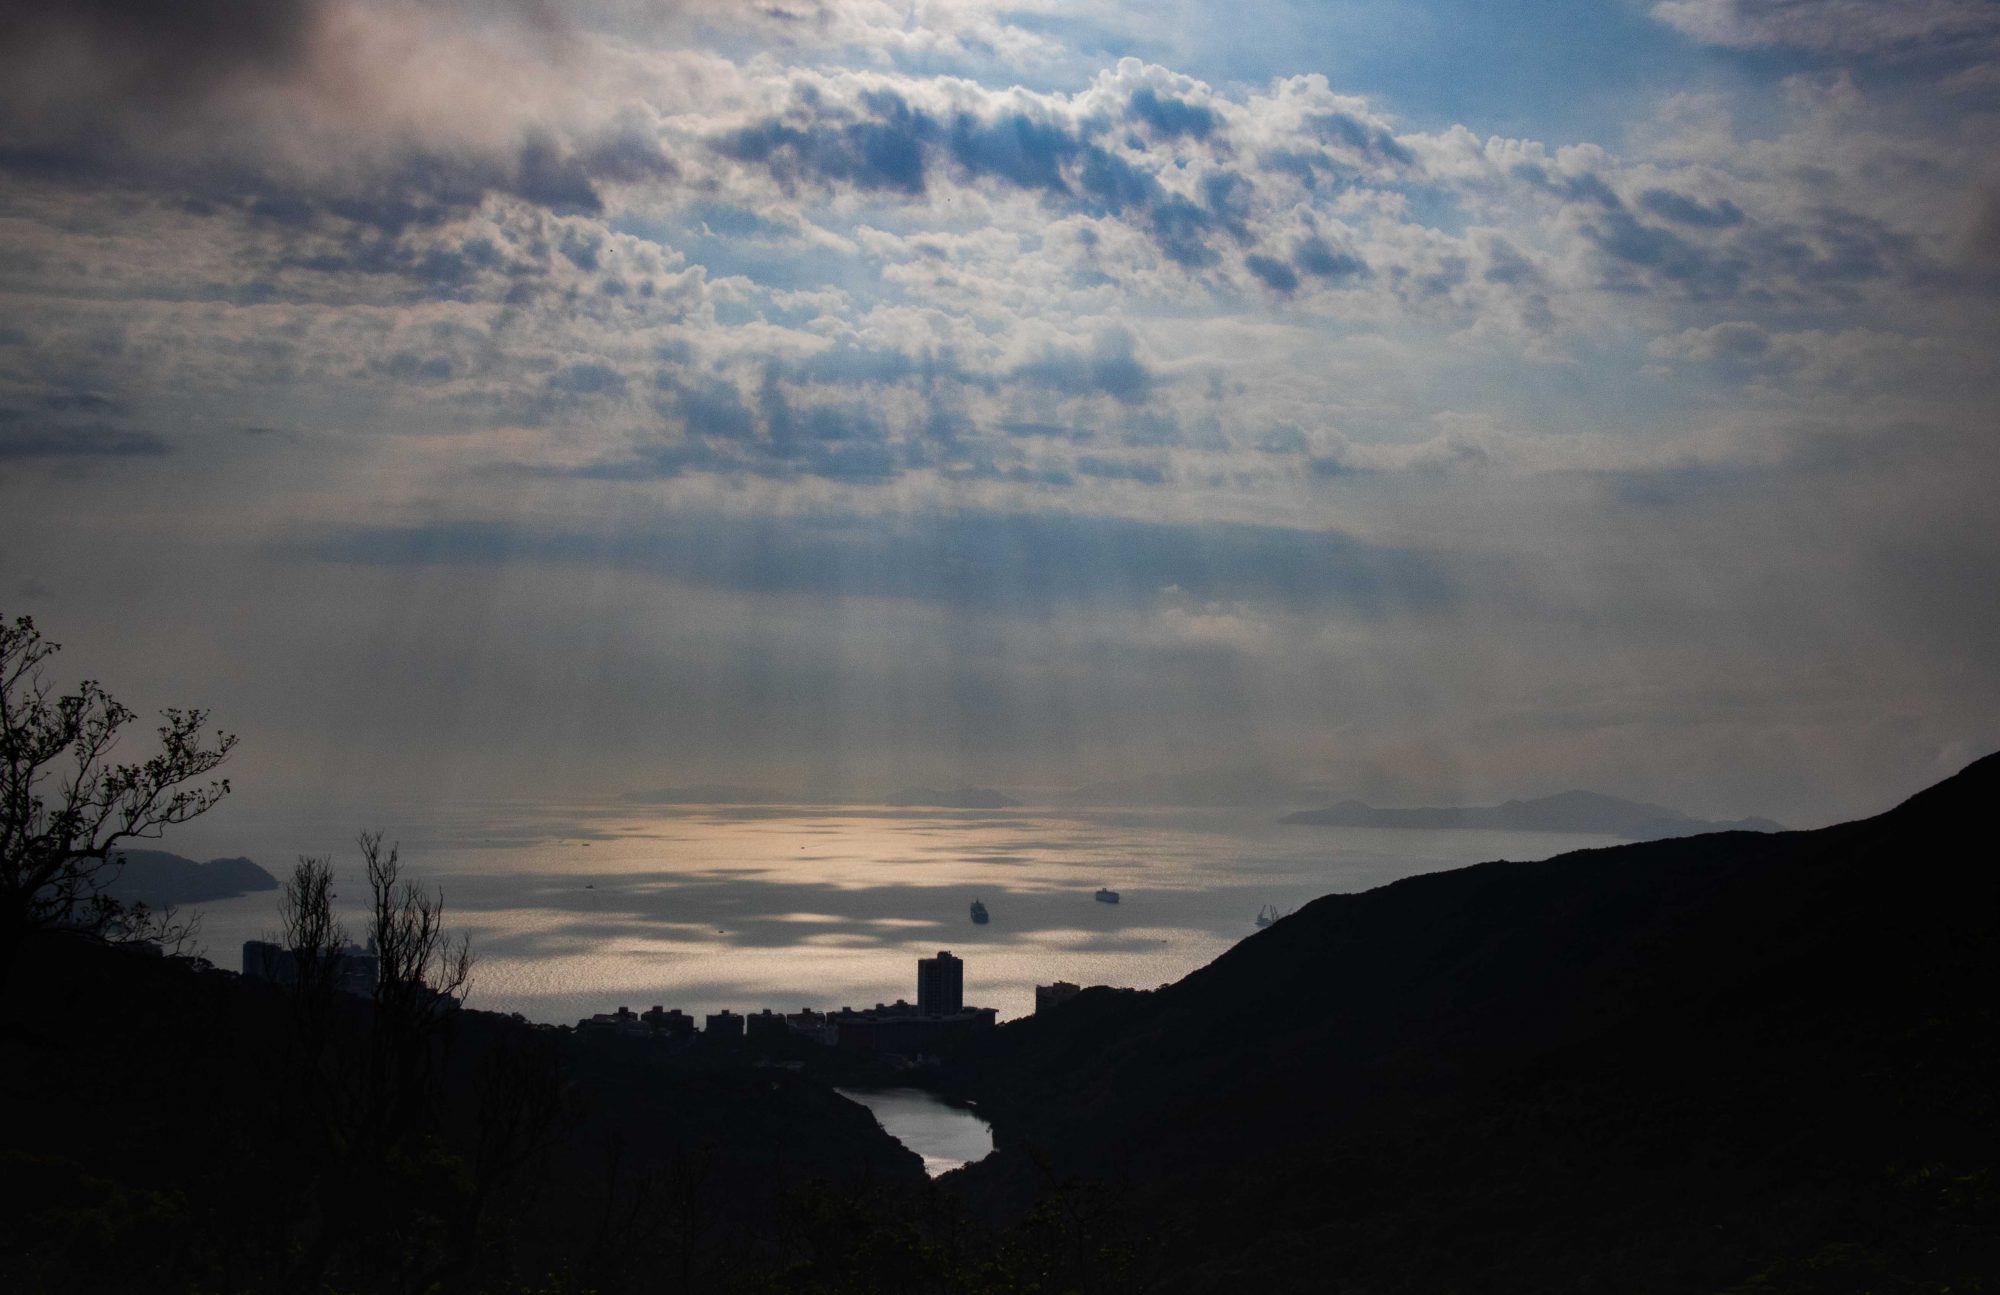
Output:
[[0, 616, 236, 981]]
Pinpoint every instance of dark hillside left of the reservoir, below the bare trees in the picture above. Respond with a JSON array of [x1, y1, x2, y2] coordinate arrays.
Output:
[[0, 937, 926, 1295]]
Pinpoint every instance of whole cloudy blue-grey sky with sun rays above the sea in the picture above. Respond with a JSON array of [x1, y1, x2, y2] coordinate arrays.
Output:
[[0, 0, 2000, 825]]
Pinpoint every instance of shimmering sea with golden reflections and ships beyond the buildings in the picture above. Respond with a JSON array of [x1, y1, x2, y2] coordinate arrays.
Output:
[[162, 803, 1614, 1023]]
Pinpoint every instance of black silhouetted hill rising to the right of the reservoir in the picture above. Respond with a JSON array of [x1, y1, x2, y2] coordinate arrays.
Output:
[[956, 757, 2000, 1293]]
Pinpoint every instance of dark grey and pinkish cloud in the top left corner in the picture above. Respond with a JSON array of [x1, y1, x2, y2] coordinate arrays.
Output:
[[0, 0, 676, 228]]
